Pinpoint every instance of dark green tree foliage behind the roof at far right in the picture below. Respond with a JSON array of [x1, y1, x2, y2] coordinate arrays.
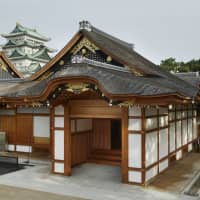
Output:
[[160, 57, 200, 72]]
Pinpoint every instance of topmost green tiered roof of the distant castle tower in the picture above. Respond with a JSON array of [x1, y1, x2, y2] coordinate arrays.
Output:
[[2, 23, 50, 41]]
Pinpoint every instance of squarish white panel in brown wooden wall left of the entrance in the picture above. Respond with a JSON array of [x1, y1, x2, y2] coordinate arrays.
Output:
[[33, 116, 50, 137]]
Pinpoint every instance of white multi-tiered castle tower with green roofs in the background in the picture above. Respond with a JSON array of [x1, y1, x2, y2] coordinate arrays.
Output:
[[2, 23, 55, 77]]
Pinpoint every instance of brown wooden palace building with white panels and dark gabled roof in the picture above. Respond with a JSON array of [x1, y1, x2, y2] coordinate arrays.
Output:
[[0, 21, 200, 185]]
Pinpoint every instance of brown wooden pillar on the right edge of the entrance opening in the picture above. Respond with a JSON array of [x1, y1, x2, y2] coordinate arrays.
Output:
[[121, 108, 128, 183]]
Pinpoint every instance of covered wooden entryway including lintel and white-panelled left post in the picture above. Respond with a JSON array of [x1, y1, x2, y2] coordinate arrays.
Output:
[[51, 100, 127, 181]]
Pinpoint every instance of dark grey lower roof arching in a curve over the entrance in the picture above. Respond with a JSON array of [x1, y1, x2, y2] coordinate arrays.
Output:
[[0, 63, 198, 97]]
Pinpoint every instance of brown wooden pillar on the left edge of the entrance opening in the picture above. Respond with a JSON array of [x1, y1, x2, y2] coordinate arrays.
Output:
[[64, 104, 71, 176]]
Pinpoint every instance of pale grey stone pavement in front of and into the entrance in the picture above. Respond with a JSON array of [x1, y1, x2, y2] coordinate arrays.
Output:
[[0, 164, 198, 200]]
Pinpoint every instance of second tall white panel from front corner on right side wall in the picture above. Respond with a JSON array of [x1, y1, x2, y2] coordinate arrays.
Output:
[[159, 128, 168, 159]]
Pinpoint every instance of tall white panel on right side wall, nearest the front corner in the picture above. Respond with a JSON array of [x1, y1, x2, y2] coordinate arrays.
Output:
[[145, 131, 158, 167]]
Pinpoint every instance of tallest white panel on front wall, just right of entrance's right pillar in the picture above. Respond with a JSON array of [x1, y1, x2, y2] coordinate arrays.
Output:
[[128, 134, 142, 168]]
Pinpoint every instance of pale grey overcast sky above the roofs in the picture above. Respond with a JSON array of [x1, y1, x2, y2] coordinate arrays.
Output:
[[0, 0, 200, 64]]
